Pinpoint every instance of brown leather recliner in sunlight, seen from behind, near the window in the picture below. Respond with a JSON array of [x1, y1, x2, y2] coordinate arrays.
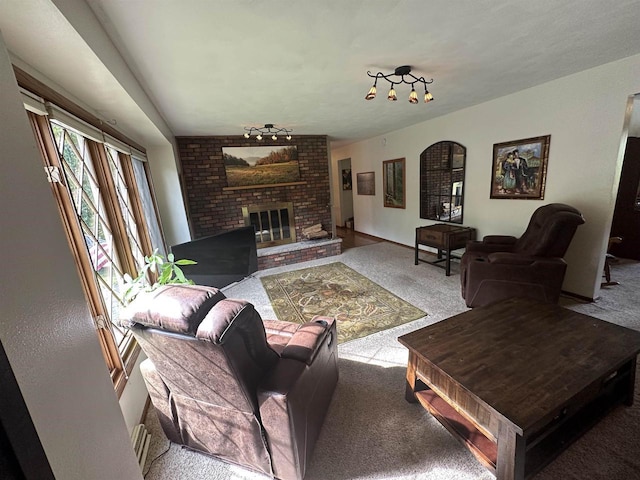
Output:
[[121, 285, 338, 480]]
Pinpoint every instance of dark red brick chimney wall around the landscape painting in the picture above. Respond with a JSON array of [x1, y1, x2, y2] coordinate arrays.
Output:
[[176, 135, 331, 239]]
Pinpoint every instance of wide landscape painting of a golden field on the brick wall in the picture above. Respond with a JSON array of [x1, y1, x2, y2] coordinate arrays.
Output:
[[222, 145, 300, 187]]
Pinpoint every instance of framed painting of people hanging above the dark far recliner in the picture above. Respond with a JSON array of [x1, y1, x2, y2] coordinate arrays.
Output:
[[490, 135, 551, 200]]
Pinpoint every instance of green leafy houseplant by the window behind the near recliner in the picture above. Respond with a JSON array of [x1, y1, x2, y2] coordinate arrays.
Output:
[[123, 248, 198, 303]]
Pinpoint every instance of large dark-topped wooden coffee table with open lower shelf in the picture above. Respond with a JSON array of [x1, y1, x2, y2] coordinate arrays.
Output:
[[398, 299, 640, 480]]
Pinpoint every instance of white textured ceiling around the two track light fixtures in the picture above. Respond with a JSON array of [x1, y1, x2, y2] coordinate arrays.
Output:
[[0, 0, 640, 144]]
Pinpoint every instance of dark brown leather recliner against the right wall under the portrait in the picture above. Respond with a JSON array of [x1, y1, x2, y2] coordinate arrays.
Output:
[[460, 203, 584, 307]]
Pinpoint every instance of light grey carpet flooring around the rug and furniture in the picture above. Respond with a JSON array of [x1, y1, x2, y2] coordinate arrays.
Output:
[[145, 242, 640, 480]]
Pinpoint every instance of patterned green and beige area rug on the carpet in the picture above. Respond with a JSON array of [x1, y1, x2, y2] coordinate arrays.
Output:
[[261, 262, 426, 343]]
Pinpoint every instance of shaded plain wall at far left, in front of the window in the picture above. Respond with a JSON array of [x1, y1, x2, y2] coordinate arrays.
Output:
[[0, 35, 142, 480]]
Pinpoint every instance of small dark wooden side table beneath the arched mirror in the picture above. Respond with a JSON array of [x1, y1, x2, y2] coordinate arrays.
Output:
[[415, 223, 476, 277]]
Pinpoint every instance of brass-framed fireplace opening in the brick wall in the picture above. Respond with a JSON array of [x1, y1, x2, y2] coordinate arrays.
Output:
[[242, 202, 296, 248]]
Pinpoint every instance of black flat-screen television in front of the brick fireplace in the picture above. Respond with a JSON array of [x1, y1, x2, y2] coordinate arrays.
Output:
[[171, 226, 258, 288]]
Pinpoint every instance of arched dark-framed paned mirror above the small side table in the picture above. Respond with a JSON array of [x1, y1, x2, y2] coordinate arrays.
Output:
[[420, 141, 467, 223]]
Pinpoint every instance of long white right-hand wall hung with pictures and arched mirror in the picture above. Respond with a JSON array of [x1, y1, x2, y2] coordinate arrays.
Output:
[[331, 55, 640, 298]]
